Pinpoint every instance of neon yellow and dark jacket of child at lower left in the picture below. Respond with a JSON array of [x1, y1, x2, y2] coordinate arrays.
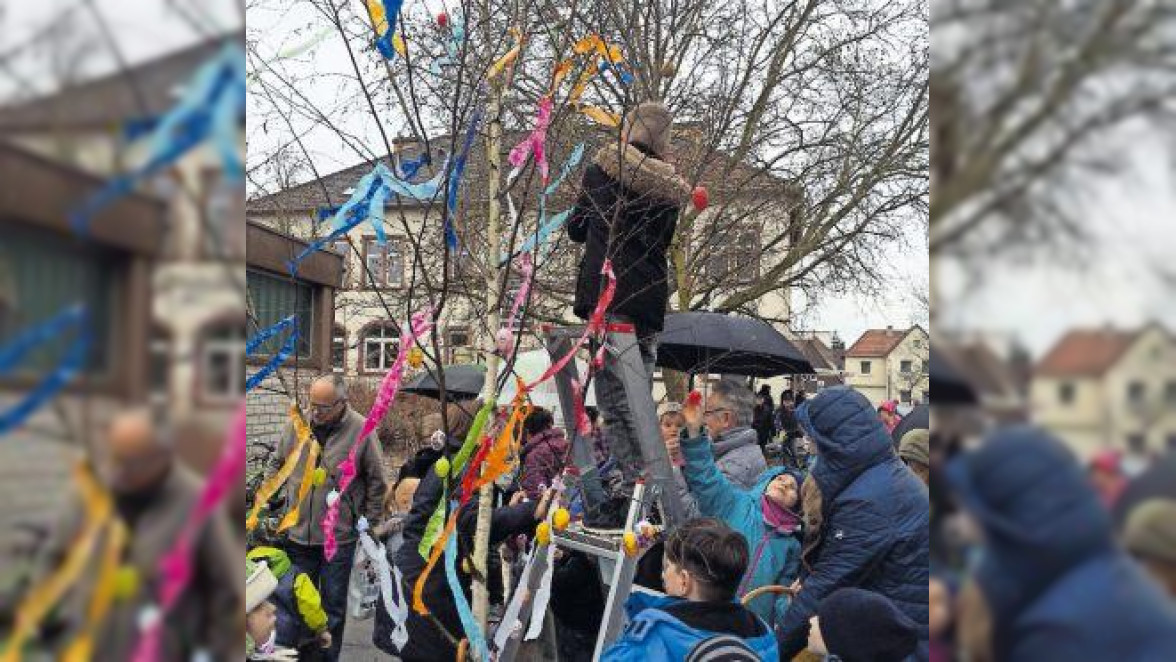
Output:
[[246, 547, 327, 648]]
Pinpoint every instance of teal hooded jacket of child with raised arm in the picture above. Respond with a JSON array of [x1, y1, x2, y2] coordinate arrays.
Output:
[[682, 432, 801, 623]]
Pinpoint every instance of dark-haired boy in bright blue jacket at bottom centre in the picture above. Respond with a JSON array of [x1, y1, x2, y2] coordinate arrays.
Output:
[[601, 517, 780, 662]]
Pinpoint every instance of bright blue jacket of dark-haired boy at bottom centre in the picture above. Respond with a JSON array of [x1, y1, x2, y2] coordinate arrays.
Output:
[[601, 591, 779, 662]]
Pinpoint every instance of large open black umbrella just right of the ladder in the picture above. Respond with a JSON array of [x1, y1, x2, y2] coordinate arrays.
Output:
[[657, 310, 813, 377]]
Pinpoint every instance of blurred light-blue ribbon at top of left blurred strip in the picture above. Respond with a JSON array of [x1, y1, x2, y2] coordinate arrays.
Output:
[[72, 42, 246, 235]]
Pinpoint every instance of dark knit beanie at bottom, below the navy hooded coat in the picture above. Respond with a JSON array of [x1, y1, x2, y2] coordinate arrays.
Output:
[[817, 588, 918, 662]]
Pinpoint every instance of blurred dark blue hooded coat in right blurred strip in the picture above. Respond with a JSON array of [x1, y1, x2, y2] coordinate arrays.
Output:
[[948, 426, 1176, 662]]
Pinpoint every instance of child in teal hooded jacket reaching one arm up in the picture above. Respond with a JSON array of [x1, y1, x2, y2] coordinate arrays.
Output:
[[681, 420, 802, 623]]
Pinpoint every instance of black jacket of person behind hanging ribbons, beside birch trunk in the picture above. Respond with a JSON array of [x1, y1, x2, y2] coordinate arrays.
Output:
[[381, 472, 536, 662]]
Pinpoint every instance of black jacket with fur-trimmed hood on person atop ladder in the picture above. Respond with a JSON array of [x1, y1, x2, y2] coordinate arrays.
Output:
[[568, 143, 690, 332]]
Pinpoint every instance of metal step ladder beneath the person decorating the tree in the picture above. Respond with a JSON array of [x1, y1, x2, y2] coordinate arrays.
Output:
[[497, 326, 684, 662]]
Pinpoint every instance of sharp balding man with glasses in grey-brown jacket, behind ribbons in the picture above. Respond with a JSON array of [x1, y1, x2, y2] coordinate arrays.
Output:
[[263, 374, 387, 662]]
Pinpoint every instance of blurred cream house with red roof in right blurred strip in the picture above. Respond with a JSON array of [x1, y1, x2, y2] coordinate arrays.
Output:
[[1029, 323, 1176, 457]]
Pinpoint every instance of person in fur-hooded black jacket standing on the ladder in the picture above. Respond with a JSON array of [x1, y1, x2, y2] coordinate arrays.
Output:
[[568, 101, 690, 528]]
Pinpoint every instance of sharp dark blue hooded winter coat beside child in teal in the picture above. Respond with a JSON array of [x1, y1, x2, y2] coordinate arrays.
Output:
[[777, 387, 930, 658]]
